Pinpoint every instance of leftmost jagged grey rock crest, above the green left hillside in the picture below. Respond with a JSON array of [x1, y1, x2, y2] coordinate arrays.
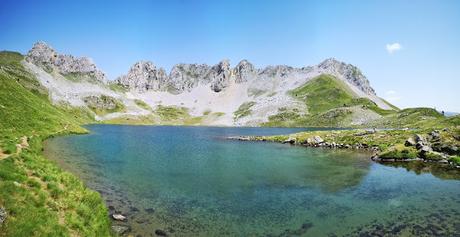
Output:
[[25, 41, 107, 83]]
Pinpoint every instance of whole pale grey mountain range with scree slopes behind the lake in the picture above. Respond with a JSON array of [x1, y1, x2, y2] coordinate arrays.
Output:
[[11, 42, 397, 126]]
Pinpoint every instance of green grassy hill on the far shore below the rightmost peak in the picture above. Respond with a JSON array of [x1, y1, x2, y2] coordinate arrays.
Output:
[[264, 75, 396, 126]]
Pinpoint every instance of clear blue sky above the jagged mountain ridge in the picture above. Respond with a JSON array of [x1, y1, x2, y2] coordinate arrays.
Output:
[[0, 0, 460, 112]]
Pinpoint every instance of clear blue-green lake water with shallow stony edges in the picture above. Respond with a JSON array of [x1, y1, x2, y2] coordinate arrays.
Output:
[[45, 125, 460, 236]]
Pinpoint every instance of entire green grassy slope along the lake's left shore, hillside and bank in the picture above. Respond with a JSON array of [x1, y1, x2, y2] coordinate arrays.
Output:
[[0, 52, 110, 236]]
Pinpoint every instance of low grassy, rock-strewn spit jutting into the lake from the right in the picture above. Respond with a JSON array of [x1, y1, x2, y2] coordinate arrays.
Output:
[[228, 128, 460, 169]]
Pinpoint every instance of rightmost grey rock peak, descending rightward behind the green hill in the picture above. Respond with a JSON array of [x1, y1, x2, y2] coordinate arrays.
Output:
[[317, 58, 375, 95]]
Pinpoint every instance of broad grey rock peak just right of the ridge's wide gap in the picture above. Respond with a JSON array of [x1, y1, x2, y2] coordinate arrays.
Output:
[[116, 61, 168, 92]]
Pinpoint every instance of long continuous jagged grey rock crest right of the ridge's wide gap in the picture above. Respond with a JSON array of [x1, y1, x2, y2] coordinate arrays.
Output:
[[111, 56, 375, 95]]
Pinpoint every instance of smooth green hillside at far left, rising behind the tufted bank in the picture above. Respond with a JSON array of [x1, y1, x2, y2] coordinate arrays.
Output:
[[0, 52, 91, 135]]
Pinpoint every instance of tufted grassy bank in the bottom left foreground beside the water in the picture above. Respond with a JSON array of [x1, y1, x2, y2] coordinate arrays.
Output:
[[0, 136, 110, 236]]
